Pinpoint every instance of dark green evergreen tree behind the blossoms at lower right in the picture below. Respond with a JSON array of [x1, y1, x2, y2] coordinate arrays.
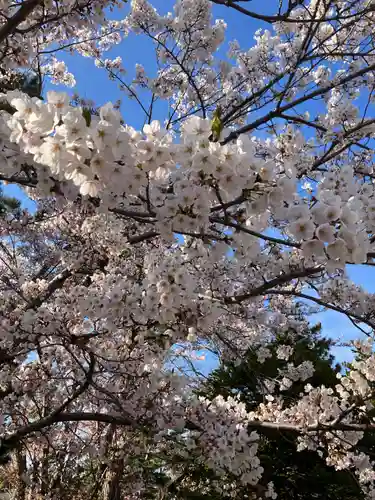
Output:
[[200, 325, 368, 500]]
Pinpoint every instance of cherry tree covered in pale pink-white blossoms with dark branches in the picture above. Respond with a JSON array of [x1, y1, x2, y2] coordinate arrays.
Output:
[[0, 0, 375, 500]]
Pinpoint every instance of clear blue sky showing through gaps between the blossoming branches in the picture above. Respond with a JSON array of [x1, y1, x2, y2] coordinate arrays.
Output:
[[6, 0, 375, 372]]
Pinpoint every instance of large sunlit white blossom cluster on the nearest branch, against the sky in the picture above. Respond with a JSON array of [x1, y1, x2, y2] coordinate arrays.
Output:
[[2, 88, 373, 270]]
